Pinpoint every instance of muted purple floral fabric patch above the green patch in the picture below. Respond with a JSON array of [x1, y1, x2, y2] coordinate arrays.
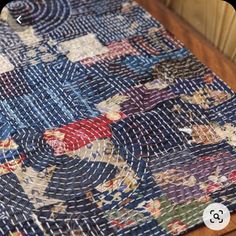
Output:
[[153, 152, 235, 203]]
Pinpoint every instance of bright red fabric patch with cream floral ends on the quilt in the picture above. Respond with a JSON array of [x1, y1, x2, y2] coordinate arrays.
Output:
[[44, 112, 124, 156]]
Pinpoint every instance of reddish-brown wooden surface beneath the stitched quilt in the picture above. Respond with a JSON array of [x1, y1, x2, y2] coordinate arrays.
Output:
[[136, 0, 236, 236]]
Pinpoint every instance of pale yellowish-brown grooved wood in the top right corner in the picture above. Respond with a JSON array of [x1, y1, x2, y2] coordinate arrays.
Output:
[[162, 0, 236, 63]]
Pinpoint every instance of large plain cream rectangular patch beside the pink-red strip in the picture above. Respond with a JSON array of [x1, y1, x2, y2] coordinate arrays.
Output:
[[60, 34, 109, 62]]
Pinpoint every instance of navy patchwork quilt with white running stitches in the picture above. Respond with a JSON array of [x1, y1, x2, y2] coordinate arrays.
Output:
[[0, 0, 236, 236]]
